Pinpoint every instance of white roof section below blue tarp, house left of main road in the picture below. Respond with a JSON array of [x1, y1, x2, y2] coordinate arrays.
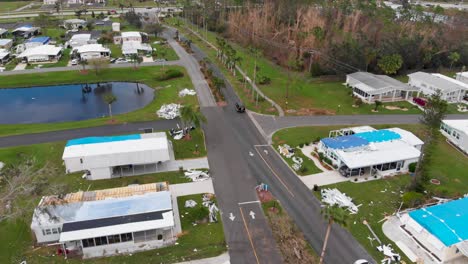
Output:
[[62, 132, 169, 159]]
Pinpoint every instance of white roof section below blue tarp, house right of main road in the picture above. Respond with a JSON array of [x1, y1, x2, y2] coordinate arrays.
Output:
[[336, 140, 421, 169]]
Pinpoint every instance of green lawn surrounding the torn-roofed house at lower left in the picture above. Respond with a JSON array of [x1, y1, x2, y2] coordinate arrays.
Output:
[[0, 142, 218, 263]]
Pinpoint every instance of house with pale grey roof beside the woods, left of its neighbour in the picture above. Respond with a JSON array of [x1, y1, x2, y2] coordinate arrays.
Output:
[[346, 72, 416, 104]]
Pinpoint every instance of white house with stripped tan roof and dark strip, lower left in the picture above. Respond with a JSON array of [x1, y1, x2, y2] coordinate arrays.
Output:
[[31, 182, 177, 258]]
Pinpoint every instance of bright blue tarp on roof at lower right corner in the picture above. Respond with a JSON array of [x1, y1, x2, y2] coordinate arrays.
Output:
[[409, 197, 468, 246]]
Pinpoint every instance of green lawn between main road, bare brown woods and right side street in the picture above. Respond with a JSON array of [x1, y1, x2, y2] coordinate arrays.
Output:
[[166, 19, 421, 115]]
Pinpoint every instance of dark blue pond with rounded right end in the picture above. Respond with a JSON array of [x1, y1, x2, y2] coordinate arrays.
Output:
[[0, 82, 154, 124]]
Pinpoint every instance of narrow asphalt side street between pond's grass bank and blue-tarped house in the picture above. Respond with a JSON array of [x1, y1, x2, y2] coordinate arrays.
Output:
[[0, 119, 179, 148]]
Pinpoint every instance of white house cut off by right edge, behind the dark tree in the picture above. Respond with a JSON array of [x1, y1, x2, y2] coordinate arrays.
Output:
[[408, 72, 468, 103]]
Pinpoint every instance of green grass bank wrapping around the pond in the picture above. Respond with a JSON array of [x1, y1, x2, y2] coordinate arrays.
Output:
[[0, 66, 198, 136]]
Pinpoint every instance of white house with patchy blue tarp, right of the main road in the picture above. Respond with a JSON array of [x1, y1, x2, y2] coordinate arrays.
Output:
[[318, 126, 424, 177]]
